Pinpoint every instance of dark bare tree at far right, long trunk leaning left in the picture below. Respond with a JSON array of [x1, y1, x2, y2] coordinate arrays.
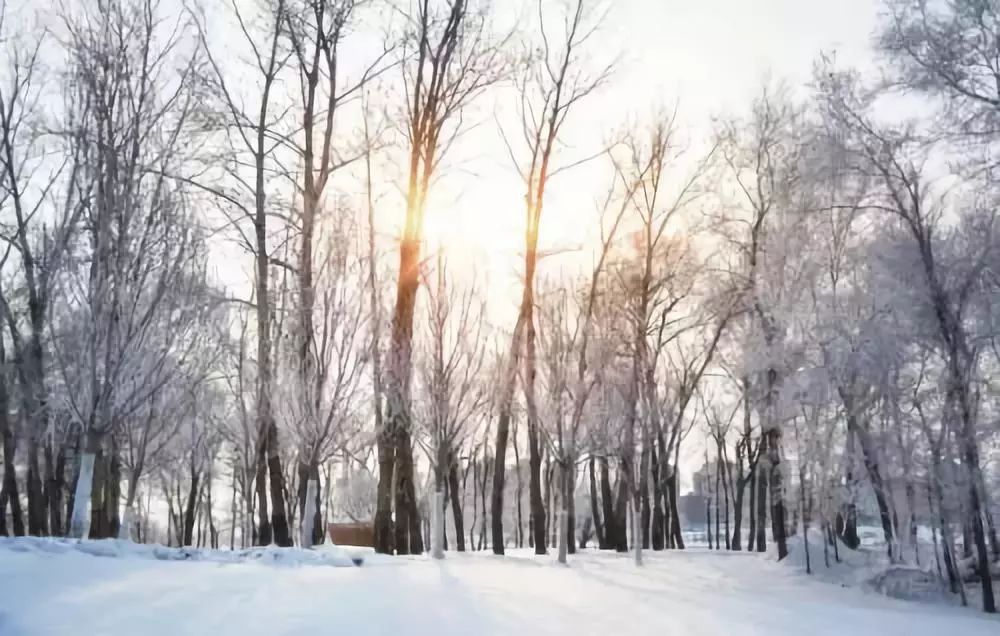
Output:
[[821, 63, 996, 613]]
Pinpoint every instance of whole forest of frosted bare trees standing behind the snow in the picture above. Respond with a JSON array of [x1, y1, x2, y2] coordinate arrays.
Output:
[[0, 0, 1000, 612]]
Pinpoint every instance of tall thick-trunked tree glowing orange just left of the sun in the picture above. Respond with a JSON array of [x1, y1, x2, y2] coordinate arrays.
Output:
[[375, 0, 505, 554]]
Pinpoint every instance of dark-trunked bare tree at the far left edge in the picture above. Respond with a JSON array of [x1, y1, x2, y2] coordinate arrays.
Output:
[[0, 2, 90, 535]]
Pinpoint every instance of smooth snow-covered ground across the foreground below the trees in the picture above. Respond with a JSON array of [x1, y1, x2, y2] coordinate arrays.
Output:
[[0, 539, 1000, 636]]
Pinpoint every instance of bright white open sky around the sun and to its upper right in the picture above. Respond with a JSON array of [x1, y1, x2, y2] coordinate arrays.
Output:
[[414, 0, 879, 322]]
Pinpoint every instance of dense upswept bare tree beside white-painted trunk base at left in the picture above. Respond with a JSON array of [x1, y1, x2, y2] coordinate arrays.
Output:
[[47, 0, 203, 537]]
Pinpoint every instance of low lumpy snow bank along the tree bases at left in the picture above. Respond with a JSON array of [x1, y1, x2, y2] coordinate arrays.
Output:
[[0, 537, 363, 567]]
